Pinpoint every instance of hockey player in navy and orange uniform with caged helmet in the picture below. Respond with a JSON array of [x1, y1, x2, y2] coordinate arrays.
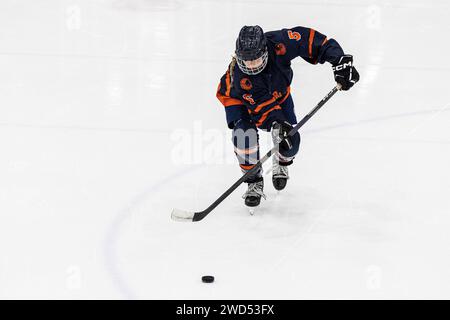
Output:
[[217, 26, 359, 207]]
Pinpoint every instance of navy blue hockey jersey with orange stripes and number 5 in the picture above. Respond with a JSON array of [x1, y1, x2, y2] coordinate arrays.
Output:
[[216, 27, 344, 130]]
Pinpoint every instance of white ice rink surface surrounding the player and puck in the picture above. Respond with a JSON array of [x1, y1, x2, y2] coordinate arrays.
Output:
[[0, 0, 450, 299]]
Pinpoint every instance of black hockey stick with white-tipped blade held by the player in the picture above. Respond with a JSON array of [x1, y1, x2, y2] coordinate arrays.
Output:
[[171, 84, 340, 222]]
